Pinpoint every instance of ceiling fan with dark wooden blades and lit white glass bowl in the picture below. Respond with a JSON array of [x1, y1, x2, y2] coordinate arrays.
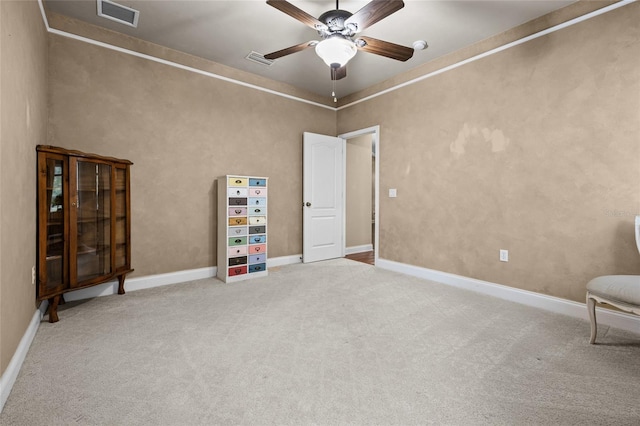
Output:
[[264, 0, 413, 80]]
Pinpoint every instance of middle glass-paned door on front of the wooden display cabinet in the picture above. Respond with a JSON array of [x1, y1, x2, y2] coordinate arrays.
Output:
[[71, 160, 111, 283]]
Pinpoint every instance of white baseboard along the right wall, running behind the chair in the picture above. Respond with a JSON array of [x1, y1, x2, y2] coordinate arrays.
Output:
[[376, 259, 640, 333]]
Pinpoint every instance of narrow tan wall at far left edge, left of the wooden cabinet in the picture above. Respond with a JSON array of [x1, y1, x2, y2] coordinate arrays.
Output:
[[0, 1, 47, 373]]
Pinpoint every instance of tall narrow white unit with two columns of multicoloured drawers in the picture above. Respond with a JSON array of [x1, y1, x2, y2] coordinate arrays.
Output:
[[218, 175, 268, 283]]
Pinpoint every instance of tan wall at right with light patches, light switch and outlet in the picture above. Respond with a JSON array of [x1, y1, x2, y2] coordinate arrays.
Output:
[[338, 3, 640, 301]]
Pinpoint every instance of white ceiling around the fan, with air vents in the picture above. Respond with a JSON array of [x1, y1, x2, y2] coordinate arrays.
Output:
[[44, 0, 574, 97]]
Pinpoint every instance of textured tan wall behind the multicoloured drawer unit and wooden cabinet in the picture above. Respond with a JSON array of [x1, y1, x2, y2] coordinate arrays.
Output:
[[49, 35, 336, 276]]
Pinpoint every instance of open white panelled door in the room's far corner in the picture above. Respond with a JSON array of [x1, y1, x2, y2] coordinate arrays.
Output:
[[302, 132, 345, 263]]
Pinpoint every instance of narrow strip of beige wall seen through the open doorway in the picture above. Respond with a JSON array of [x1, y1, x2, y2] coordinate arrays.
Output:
[[345, 134, 373, 248]]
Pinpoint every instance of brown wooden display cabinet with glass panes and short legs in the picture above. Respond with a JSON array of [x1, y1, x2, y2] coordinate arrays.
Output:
[[36, 145, 133, 322]]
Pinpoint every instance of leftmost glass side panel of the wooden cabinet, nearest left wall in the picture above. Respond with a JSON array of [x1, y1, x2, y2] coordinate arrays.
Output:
[[40, 157, 66, 295]]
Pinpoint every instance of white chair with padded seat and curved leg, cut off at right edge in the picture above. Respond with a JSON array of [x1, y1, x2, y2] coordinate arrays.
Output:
[[587, 216, 640, 344]]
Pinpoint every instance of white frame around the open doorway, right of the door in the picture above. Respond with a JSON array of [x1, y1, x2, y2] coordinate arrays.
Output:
[[338, 125, 380, 265]]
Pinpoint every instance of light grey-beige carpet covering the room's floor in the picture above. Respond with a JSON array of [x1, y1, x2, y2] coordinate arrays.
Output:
[[0, 259, 640, 425]]
